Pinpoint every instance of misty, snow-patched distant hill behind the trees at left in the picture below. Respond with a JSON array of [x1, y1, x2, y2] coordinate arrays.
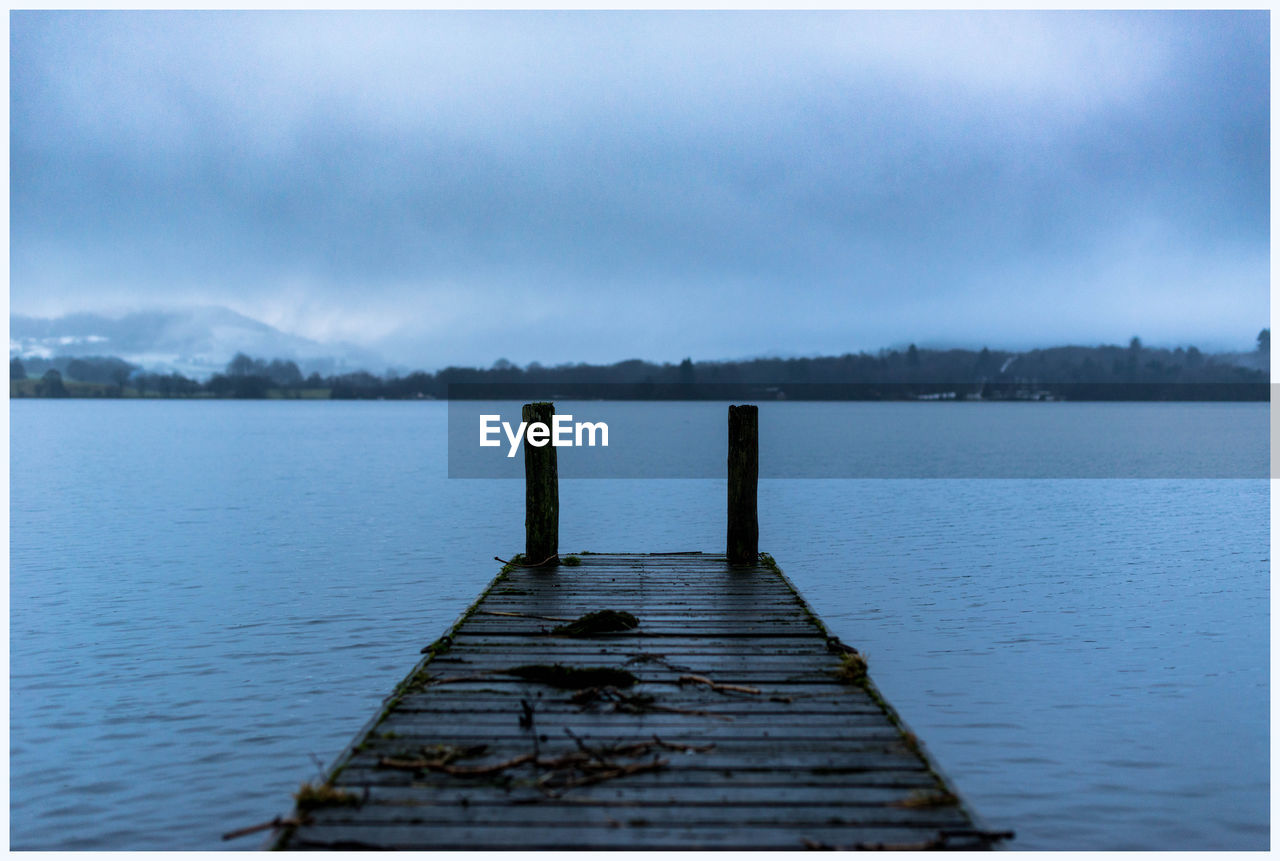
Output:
[[9, 306, 385, 379]]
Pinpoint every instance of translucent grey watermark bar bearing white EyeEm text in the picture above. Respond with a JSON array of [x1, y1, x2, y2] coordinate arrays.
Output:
[[448, 384, 1270, 478]]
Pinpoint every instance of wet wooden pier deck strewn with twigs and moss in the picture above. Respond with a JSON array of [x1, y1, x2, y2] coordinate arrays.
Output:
[[273, 554, 1002, 849]]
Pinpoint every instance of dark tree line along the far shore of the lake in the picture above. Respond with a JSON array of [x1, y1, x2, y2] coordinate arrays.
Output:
[[9, 329, 1270, 399]]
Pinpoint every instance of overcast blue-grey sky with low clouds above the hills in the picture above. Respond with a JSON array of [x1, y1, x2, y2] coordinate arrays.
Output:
[[10, 12, 1270, 367]]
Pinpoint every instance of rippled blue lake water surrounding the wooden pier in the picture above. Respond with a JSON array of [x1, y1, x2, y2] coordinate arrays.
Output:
[[9, 400, 1270, 849]]
